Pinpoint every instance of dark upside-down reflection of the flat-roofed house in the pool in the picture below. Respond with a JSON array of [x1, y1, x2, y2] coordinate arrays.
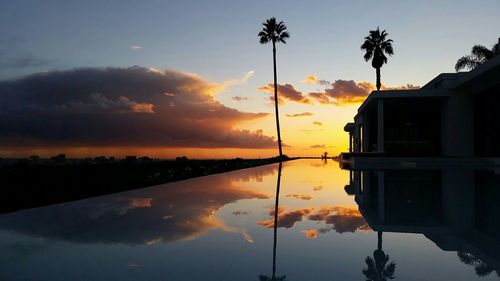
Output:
[[351, 168, 500, 273]]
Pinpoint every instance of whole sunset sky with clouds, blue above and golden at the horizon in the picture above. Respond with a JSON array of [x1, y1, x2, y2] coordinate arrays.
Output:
[[0, 0, 500, 158]]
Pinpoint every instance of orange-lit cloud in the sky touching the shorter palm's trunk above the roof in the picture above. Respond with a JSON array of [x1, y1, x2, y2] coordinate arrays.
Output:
[[308, 79, 420, 106]]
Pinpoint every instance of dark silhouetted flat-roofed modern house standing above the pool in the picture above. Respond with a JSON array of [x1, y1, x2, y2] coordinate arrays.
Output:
[[343, 56, 500, 160]]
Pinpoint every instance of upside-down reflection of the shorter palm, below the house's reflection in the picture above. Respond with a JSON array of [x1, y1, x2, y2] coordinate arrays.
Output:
[[363, 231, 396, 281]]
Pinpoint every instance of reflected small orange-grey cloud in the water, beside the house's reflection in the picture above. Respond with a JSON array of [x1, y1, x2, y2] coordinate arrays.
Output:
[[308, 206, 370, 233]]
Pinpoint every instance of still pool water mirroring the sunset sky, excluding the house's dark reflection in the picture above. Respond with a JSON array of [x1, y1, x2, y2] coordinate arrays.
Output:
[[0, 160, 500, 281]]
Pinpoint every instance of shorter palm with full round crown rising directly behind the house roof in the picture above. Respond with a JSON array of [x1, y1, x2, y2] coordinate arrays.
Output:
[[361, 27, 394, 91]]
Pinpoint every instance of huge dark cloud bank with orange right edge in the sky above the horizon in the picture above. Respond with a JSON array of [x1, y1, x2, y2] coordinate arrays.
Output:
[[0, 67, 275, 148]]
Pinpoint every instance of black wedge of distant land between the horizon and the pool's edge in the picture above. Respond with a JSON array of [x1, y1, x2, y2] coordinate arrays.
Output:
[[0, 157, 289, 213]]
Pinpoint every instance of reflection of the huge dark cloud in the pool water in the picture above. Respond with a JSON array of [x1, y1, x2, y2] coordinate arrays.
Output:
[[0, 165, 277, 245]]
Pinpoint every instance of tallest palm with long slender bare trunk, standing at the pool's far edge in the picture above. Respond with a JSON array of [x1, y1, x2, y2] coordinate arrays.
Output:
[[258, 17, 290, 158]]
